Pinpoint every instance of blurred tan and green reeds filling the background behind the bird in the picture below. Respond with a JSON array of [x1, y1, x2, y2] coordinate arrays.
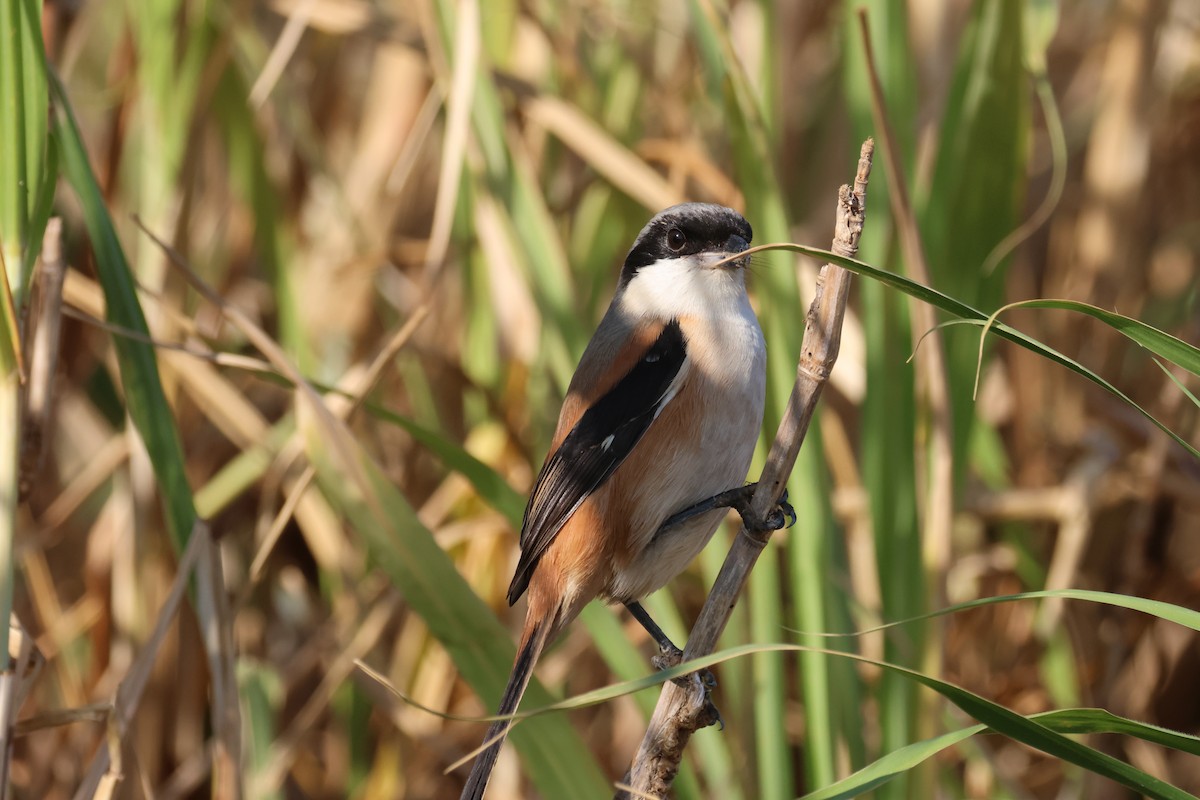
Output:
[[0, 0, 1200, 800]]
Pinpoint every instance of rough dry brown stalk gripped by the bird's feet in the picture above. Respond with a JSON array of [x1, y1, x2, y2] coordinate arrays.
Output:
[[616, 139, 875, 799]]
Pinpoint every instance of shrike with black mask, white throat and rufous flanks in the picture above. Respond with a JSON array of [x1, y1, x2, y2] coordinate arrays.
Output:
[[461, 203, 767, 800]]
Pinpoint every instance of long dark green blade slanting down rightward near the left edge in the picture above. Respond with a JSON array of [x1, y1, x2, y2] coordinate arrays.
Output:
[[50, 73, 196, 553]]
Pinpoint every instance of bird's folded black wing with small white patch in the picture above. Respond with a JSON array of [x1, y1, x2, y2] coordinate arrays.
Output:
[[509, 320, 688, 606]]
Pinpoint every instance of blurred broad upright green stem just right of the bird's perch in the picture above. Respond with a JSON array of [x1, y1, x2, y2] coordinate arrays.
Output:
[[841, 0, 925, 800]]
